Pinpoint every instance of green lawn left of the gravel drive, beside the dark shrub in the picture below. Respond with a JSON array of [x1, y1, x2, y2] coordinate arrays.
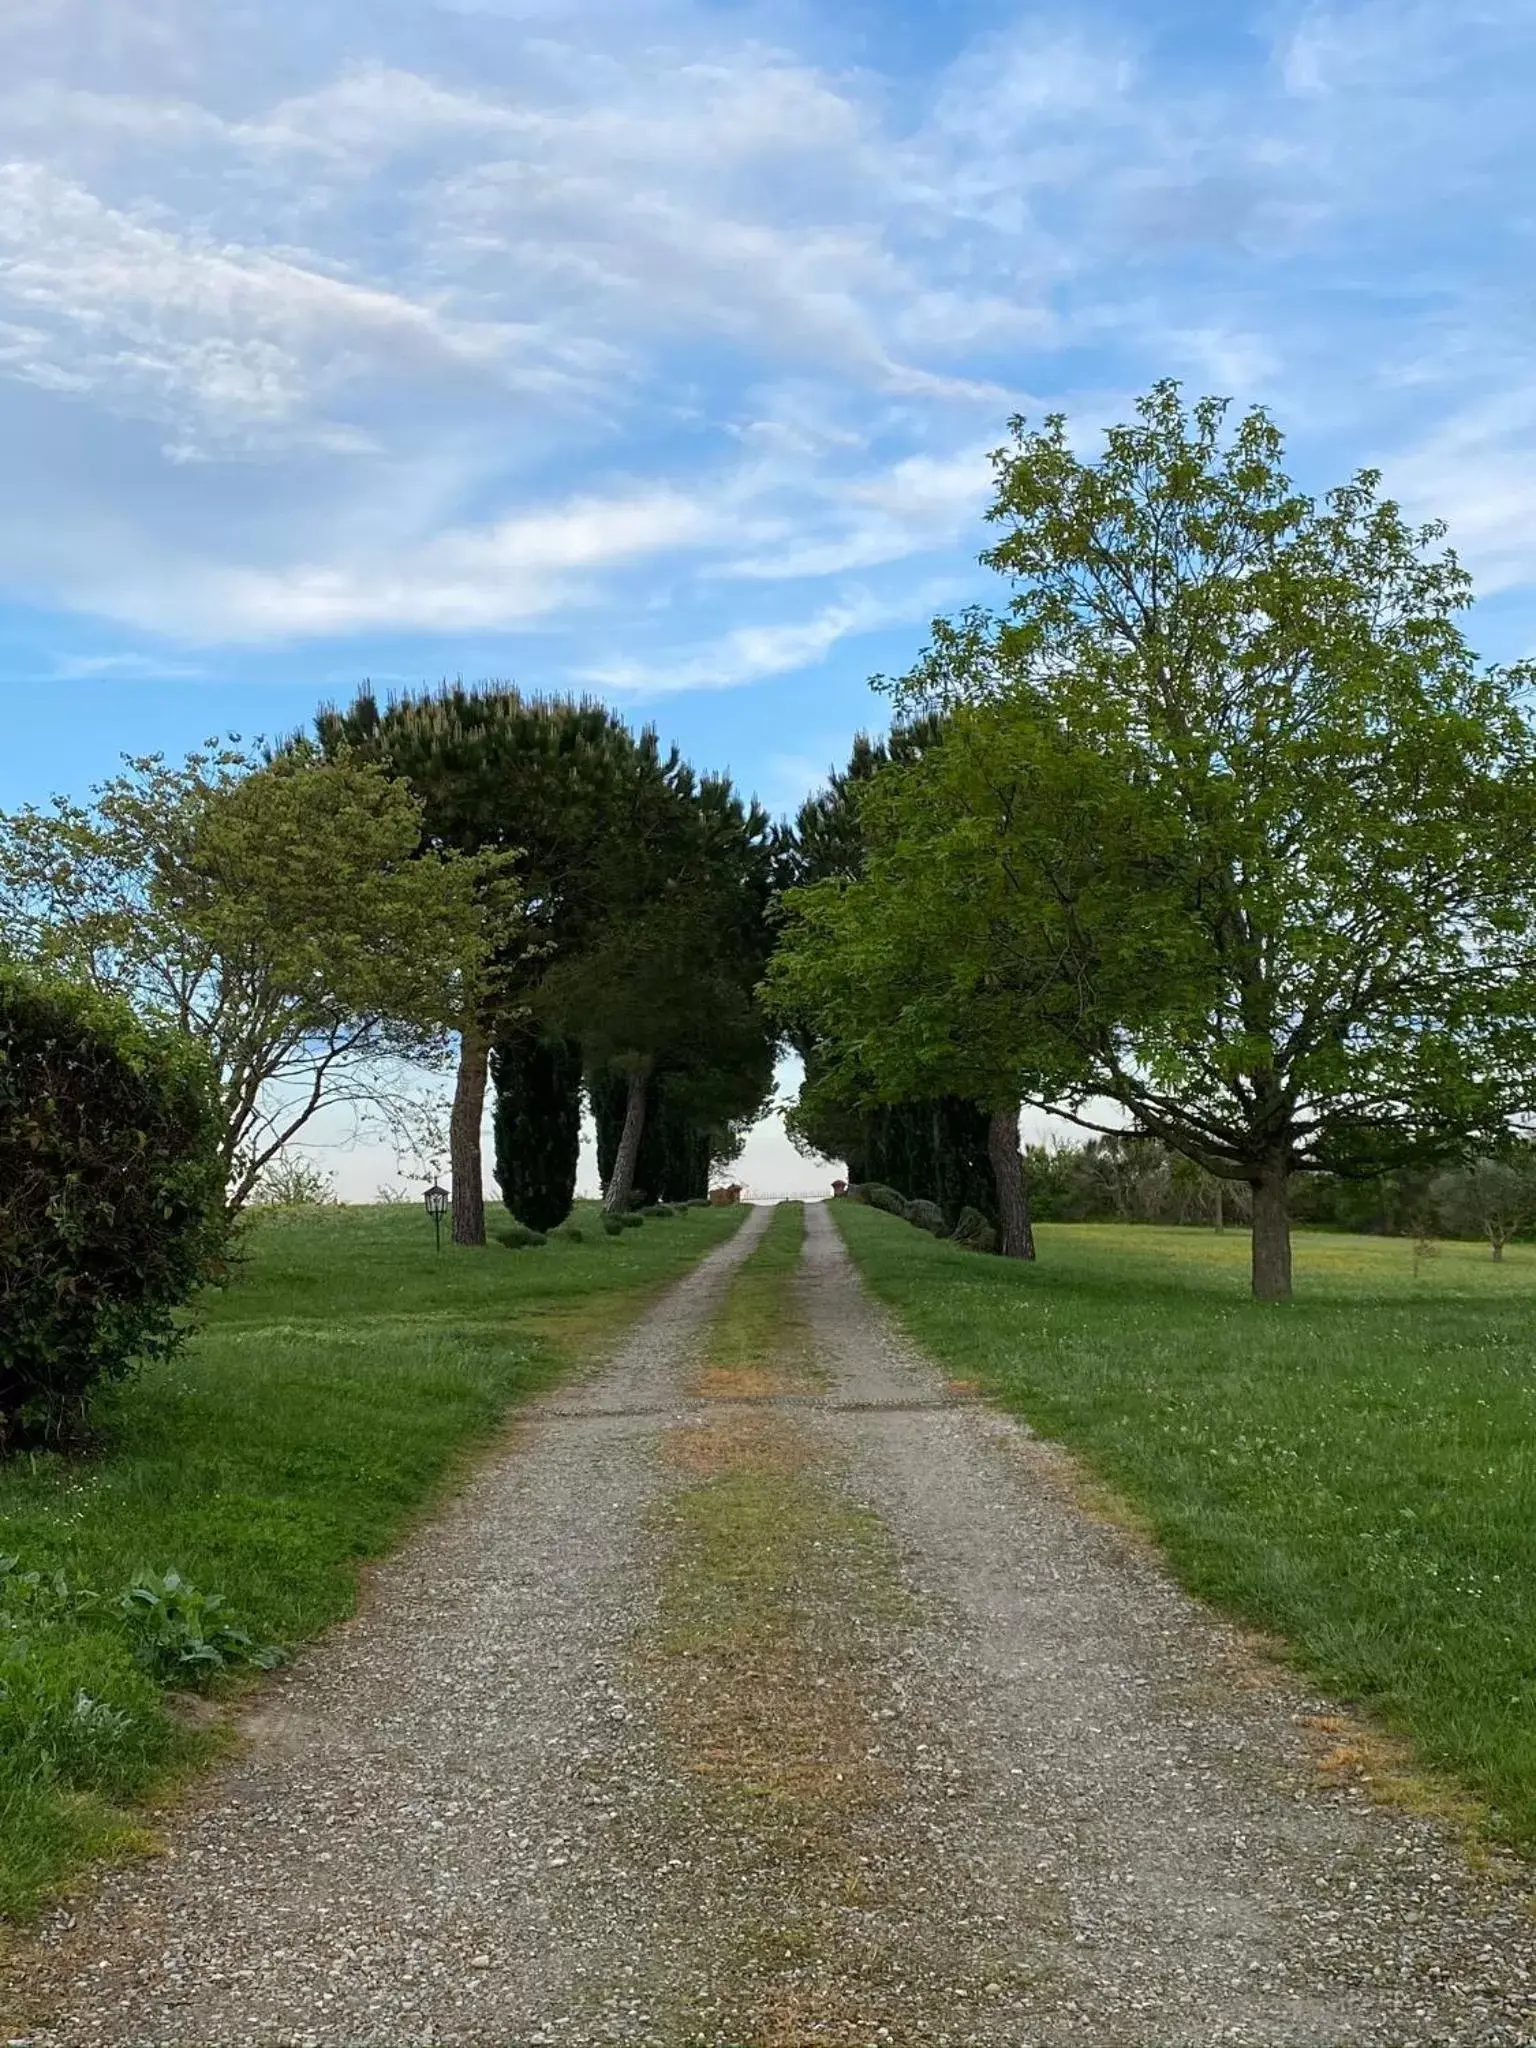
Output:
[[0, 1204, 745, 1915]]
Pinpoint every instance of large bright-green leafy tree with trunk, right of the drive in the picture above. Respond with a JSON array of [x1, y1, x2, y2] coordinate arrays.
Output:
[[774, 385, 1536, 1294]]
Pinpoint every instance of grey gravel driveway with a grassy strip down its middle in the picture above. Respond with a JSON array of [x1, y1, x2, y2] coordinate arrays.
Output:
[[0, 1208, 1536, 2048]]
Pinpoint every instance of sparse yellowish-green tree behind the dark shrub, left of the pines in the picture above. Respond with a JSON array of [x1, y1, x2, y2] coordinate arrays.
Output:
[[0, 743, 514, 1210]]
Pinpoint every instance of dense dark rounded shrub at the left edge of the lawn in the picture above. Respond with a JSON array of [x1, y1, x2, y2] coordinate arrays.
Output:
[[0, 967, 225, 1448]]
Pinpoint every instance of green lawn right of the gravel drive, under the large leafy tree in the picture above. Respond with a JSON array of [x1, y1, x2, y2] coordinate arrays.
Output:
[[834, 1202, 1536, 1849]]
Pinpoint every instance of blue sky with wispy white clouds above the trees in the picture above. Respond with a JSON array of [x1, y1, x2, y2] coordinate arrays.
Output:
[[0, 0, 1536, 1196]]
